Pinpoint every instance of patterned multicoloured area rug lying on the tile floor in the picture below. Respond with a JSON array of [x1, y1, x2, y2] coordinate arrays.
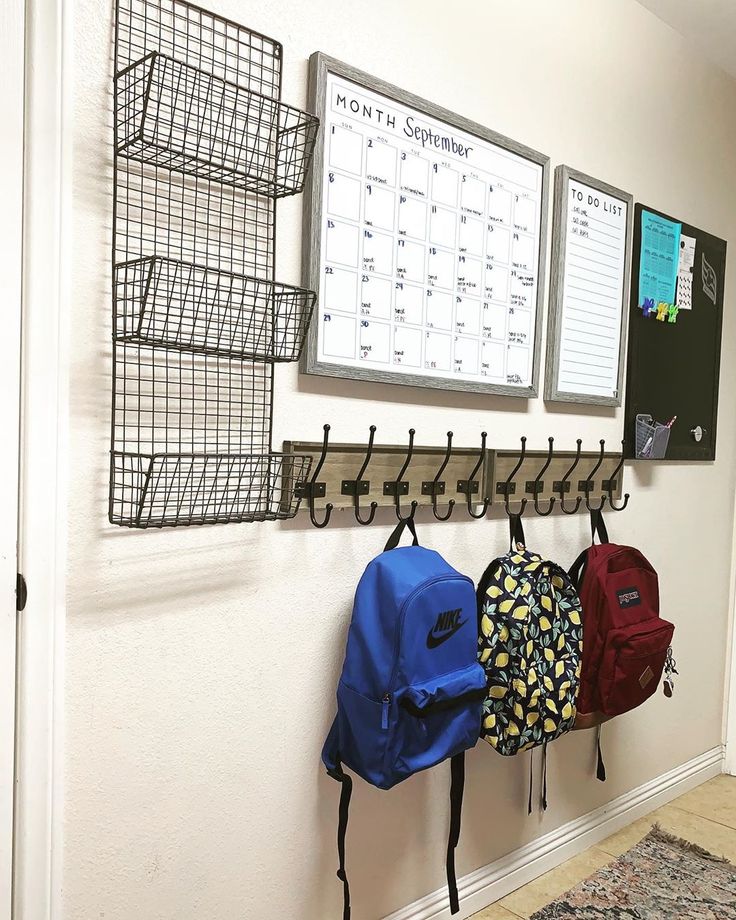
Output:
[[531, 826, 736, 920]]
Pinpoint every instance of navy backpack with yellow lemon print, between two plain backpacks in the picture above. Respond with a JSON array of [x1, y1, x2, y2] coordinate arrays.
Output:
[[476, 514, 583, 798]]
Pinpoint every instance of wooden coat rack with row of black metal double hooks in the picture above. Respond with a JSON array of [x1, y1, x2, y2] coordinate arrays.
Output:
[[284, 425, 629, 527]]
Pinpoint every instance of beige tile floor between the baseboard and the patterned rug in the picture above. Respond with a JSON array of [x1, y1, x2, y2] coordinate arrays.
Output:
[[473, 776, 736, 920]]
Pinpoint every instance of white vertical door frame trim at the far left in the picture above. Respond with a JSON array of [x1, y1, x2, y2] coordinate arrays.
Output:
[[13, 0, 72, 920]]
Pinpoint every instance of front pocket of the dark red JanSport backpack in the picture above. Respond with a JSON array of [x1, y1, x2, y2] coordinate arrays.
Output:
[[599, 617, 675, 716]]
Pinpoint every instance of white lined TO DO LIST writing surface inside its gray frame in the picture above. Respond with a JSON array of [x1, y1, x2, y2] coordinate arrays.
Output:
[[557, 179, 629, 399]]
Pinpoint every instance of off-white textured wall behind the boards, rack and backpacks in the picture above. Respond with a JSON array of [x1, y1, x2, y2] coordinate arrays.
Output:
[[63, 0, 736, 920]]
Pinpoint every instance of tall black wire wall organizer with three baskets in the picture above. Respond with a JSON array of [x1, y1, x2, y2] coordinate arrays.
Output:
[[109, 0, 318, 528]]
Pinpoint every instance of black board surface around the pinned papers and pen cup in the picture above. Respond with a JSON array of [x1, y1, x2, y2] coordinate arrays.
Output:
[[625, 204, 726, 460]]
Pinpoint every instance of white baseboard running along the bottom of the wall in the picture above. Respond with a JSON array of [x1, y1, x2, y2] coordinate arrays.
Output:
[[384, 746, 723, 920]]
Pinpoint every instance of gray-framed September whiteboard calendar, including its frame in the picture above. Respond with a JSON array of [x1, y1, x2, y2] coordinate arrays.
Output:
[[302, 53, 549, 397]]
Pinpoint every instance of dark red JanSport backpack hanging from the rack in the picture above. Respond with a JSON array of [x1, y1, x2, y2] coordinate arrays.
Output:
[[570, 511, 675, 736]]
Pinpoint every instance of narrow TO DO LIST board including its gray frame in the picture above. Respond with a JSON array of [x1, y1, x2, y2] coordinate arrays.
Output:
[[545, 166, 633, 406]]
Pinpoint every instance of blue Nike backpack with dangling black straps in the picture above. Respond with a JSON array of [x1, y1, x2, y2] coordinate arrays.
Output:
[[322, 518, 486, 920]]
